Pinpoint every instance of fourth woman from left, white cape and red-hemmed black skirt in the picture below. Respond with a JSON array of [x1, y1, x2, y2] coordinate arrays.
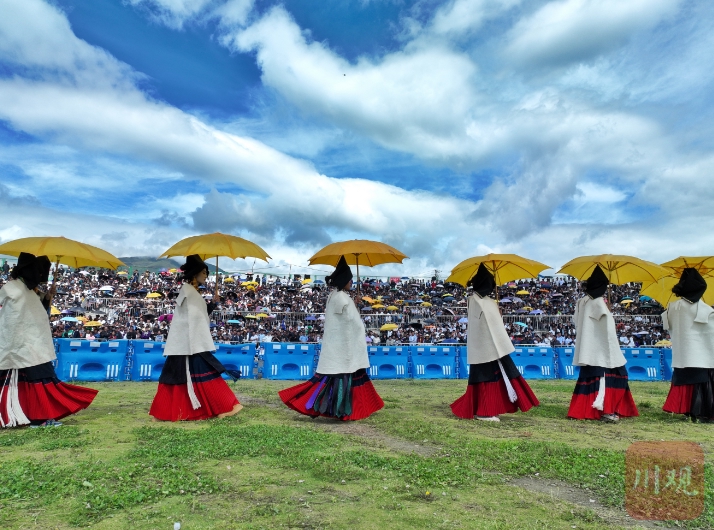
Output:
[[451, 263, 540, 421]]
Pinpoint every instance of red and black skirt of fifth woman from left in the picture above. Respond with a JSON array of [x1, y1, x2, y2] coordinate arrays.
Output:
[[568, 368, 640, 420]]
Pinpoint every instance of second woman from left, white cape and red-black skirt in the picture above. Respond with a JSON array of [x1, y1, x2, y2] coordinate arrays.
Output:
[[149, 254, 243, 421]]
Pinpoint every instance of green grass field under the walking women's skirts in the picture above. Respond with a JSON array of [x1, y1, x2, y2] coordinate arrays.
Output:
[[0, 380, 714, 530]]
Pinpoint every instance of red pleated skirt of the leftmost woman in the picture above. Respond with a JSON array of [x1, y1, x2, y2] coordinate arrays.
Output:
[[0, 363, 99, 424]]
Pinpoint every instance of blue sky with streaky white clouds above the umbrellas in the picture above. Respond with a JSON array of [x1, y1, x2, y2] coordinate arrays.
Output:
[[0, 0, 714, 275]]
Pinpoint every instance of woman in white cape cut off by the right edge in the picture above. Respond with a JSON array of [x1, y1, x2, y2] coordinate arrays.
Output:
[[662, 268, 714, 422]]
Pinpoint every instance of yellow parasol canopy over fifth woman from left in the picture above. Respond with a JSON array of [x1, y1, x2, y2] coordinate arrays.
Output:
[[558, 254, 669, 285]]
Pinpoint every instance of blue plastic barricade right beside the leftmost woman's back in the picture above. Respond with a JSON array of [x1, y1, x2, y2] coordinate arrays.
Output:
[[57, 339, 129, 381]]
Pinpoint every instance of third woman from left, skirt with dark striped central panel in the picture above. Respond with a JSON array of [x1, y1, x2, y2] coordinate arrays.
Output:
[[278, 256, 384, 421]]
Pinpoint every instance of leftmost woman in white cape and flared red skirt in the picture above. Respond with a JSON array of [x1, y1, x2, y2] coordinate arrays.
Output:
[[0, 252, 97, 427]]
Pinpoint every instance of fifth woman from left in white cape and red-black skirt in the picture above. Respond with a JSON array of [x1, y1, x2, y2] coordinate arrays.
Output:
[[568, 265, 639, 421]]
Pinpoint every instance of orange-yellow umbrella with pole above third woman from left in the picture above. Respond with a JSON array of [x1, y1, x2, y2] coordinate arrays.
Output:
[[308, 239, 409, 291]]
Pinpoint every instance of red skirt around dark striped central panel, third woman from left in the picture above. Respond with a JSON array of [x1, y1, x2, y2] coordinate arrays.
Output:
[[278, 369, 384, 421]]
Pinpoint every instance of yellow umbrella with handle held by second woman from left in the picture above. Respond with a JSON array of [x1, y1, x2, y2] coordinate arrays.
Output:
[[159, 232, 270, 296]]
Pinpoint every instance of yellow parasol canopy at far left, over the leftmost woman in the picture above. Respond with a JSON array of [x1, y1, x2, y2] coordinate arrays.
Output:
[[0, 236, 124, 270]]
